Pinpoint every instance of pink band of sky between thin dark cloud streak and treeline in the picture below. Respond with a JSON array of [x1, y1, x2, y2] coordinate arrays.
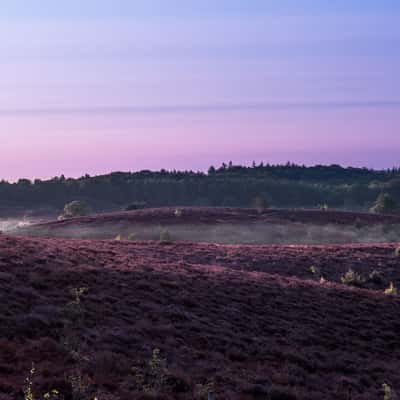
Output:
[[0, 109, 400, 179]]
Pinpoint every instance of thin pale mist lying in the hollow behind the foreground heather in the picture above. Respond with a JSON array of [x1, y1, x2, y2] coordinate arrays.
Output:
[[9, 221, 400, 245]]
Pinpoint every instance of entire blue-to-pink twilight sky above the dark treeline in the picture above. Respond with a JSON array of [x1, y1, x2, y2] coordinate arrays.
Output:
[[0, 0, 400, 180]]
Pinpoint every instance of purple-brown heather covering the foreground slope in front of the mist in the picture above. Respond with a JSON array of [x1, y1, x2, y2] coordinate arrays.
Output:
[[0, 220, 400, 400]]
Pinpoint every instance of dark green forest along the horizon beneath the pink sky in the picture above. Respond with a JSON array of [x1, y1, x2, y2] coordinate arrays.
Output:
[[0, 162, 400, 212]]
